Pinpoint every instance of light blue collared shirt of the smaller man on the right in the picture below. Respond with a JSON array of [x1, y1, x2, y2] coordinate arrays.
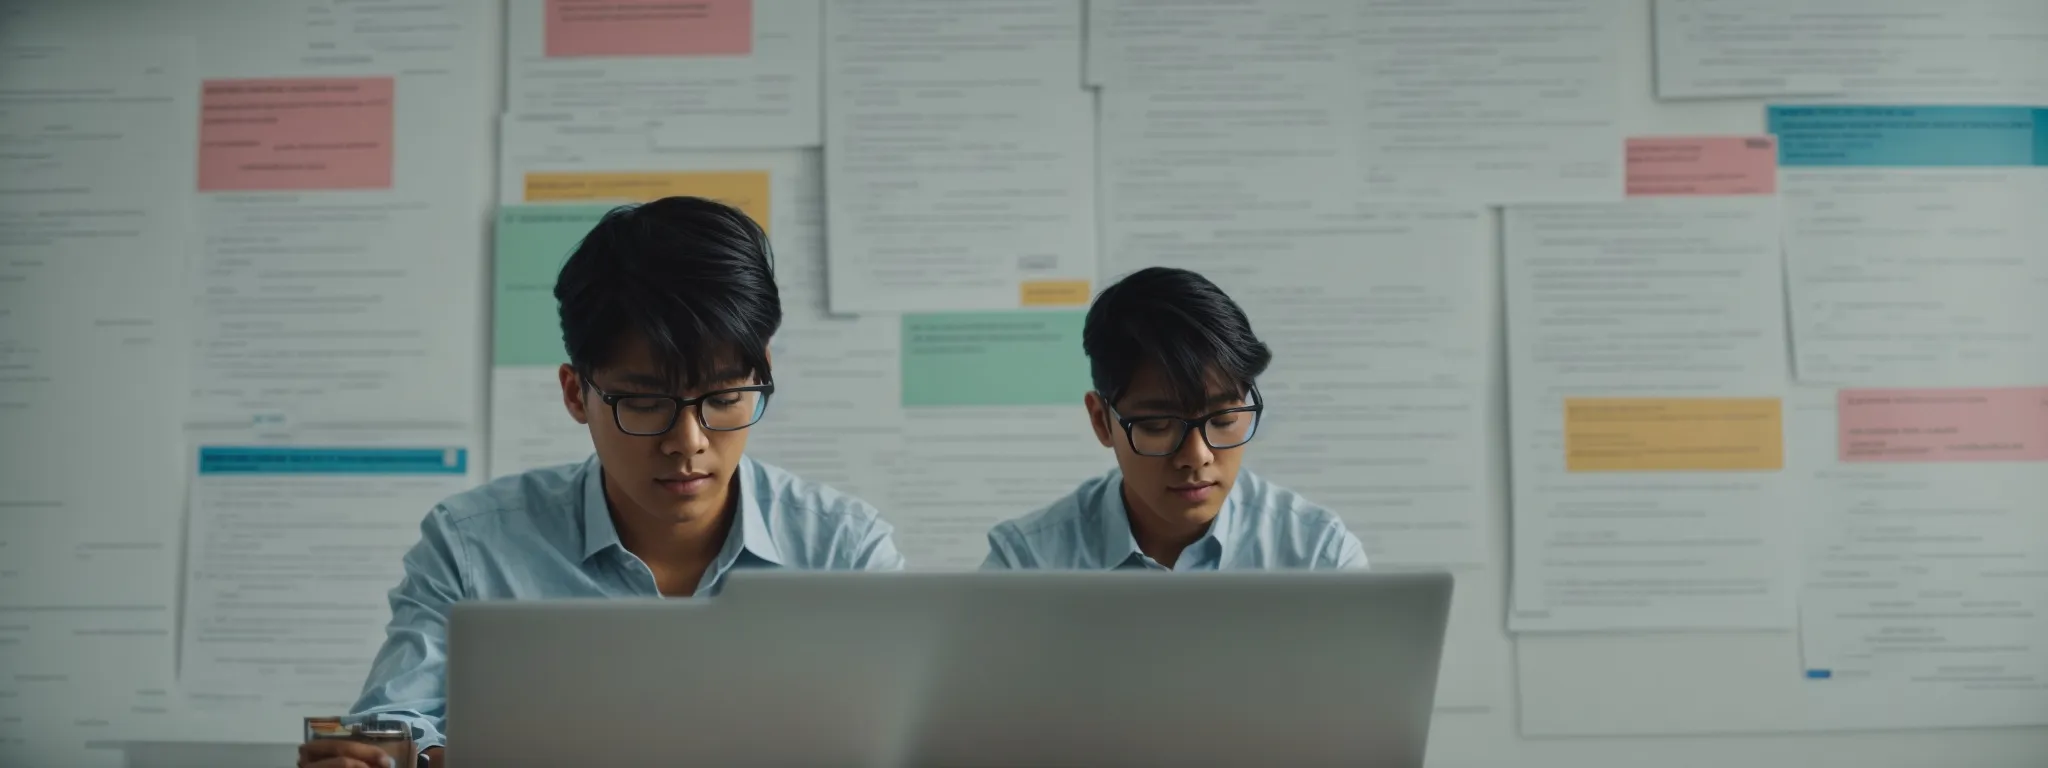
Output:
[[981, 469, 1366, 571]]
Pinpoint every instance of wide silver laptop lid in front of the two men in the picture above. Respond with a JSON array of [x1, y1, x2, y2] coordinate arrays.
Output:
[[449, 571, 1450, 768]]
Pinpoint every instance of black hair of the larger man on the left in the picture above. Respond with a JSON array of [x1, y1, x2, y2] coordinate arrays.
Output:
[[555, 197, 782, 391]]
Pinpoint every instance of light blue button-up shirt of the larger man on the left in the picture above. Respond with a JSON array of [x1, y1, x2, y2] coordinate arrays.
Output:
[[354, 457, 903, 750]]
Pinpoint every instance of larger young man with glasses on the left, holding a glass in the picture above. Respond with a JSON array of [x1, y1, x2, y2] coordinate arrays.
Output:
[[299, 197, 903, 766]]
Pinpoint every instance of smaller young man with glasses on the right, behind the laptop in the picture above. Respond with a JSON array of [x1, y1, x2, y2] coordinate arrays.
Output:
[[981, 266, 1366, 571]]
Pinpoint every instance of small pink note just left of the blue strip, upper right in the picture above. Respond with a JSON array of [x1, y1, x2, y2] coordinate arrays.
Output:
[[1628, 135, 1778, 197]]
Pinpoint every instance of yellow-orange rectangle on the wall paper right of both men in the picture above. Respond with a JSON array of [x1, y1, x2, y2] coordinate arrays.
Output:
[[1565, 397, 1786, 471]]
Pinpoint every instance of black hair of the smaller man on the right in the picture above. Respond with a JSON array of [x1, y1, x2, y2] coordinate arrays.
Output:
[[1081, 266, 1274, 414]]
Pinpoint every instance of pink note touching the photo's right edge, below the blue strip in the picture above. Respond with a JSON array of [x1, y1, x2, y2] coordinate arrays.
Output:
[[1835, 387, 2048, 461]]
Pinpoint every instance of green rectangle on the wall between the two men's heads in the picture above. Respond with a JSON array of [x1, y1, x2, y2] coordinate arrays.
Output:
[[903, 309, 1090, 408]]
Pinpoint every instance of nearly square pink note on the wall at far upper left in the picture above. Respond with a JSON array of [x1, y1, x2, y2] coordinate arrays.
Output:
[[199, 78, 393, 193]]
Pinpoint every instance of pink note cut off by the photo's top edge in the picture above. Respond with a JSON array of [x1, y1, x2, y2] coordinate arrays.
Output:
[[545, 0, 754, 57]]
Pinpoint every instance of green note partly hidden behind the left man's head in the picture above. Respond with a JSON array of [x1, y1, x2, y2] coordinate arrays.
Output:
[[492, 205, 612, 365]]
